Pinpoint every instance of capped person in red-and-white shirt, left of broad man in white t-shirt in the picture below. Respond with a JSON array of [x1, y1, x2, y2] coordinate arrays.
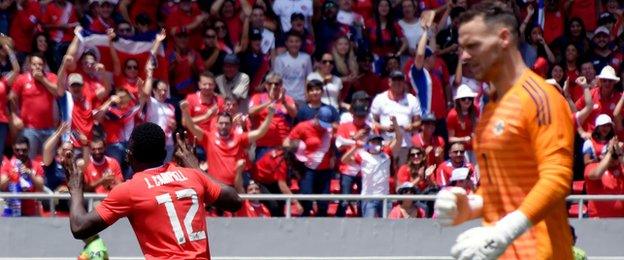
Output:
[[335, 103, 370, 217]]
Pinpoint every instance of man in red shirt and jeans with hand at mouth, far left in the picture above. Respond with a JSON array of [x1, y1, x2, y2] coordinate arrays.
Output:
[[9, 56, 64, 158]]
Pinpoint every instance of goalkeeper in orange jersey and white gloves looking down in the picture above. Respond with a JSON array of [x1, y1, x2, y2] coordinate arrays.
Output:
[[435, 1, 574, 259]]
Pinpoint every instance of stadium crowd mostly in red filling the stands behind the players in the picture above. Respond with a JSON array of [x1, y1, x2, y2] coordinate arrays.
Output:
[[0, 0, 624, 218]]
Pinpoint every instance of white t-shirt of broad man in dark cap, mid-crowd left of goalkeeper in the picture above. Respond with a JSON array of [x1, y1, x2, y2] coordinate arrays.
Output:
[[371, 91, 422, 147]]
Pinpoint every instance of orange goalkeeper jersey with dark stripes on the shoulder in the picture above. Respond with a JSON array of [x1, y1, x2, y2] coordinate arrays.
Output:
[[474, 69, 574, 259]]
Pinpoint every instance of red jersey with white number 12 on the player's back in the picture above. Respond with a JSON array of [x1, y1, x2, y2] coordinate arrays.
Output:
[[96, 164, 221, 259]]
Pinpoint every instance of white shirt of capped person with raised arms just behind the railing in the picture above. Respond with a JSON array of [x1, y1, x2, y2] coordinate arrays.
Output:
[[355, 149, 392, 195]]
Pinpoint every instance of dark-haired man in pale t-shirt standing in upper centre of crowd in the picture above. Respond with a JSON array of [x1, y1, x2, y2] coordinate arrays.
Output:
[[272, 31, 312, 101]]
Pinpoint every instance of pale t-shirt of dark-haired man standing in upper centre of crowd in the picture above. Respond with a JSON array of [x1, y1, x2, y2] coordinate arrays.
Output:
[[273, 52, 312, 101]]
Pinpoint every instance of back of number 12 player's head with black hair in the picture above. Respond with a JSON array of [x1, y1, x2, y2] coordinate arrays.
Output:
[[128, 123, 167, 164]]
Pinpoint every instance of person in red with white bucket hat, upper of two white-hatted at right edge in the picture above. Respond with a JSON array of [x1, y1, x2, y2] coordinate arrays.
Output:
[[576, 65, 622, 132]]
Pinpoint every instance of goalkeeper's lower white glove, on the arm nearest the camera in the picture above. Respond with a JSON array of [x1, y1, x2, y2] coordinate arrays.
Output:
[[451, 210, 531, 260]]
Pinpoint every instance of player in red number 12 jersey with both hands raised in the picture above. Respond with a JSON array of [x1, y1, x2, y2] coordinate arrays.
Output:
[[63, 123, 242, 259]]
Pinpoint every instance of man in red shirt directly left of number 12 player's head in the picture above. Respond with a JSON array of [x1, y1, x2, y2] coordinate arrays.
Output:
[[83, 138, 124, 194]]
